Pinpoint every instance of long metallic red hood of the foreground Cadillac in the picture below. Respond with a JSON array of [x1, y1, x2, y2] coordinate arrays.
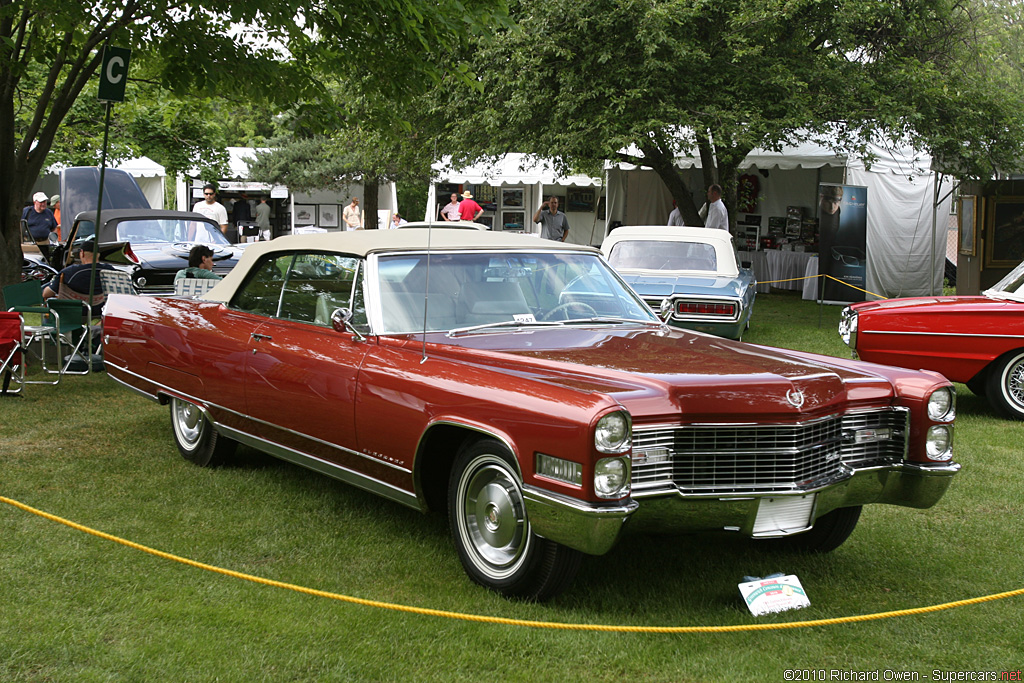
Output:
[[410, 329, 893, 422]]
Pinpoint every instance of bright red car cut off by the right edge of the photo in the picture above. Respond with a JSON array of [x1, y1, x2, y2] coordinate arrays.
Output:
[[839, 263, 1024, 420]]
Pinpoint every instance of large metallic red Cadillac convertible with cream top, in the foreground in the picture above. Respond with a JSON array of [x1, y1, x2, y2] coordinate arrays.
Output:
[[103, 229, 959, 600]]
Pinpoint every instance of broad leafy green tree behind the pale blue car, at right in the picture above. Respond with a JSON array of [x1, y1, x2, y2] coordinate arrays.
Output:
[[446, 0, 1024, 224]]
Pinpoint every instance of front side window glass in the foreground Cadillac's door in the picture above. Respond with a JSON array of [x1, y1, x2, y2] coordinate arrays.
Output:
[[278, 253, 359, 327]]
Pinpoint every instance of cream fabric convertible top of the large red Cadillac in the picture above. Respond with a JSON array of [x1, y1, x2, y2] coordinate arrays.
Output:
[[202, 228, 600, 303]]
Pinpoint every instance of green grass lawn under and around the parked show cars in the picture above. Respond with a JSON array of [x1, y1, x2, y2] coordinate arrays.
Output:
[[0, 294, 1024, 682]]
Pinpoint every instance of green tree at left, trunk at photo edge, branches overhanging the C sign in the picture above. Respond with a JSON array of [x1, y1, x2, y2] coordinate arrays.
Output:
[[0, 0, 504, 301]]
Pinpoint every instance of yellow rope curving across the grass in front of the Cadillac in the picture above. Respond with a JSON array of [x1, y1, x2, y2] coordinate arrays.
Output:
[[0, 496, 1024, 634]]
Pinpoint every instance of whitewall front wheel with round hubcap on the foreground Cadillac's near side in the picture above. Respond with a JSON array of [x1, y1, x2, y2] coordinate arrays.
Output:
[[449, 439, 582, 601]]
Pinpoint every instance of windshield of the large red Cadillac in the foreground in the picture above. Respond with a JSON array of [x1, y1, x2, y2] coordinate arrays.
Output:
[[377, 253, 658, 334]]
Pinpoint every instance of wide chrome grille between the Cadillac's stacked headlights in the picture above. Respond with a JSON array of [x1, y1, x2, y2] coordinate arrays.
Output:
[[633, 410, 907, 494]]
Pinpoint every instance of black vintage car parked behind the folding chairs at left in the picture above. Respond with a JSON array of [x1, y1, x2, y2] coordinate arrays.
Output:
[[59, 209, 245, 294]]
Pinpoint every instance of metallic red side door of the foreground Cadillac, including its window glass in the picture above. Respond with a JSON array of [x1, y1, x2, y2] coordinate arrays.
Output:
[[240, 252, 372, 469]]
